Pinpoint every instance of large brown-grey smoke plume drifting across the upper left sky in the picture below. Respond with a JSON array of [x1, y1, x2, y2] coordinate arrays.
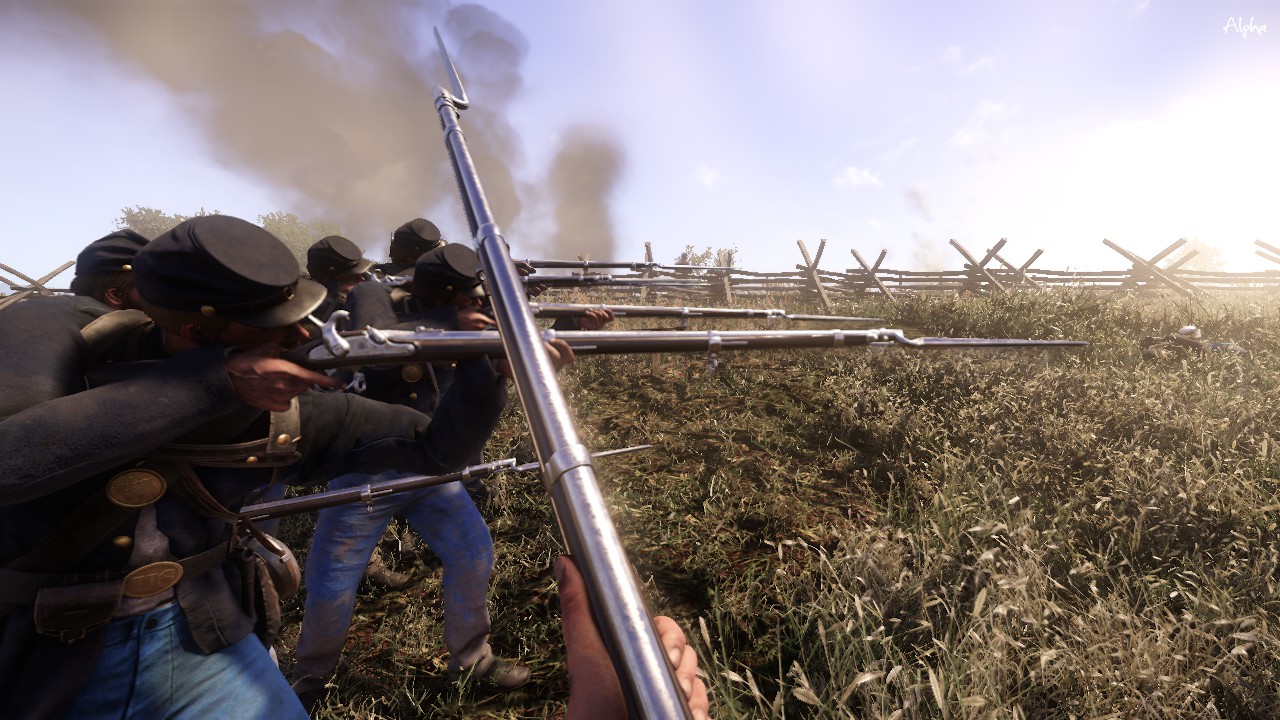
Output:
[[26, 0, 537, 256]]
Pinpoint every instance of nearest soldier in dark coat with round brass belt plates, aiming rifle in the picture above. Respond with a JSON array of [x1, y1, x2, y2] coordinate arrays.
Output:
[[0, 215, 506, 717]]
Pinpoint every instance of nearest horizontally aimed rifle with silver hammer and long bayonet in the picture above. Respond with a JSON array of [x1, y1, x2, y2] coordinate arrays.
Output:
[[284, 310, 1088, 370]]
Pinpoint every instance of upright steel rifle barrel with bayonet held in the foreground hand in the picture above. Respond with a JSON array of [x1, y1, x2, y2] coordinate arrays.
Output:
[[434, 29, 691, 720]]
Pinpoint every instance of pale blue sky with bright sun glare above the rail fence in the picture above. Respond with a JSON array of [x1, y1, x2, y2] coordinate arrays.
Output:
[[0, 0, 1280, 285]]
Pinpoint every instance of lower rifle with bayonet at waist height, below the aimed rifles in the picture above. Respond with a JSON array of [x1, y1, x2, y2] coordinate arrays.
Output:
[[239, 445, 653, 520]]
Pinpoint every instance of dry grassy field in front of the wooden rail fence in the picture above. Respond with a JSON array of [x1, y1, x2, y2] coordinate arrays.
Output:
[[280, 291, 1280, 719]]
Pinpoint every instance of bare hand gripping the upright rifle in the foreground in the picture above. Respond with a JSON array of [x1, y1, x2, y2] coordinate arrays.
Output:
[[556, 556, 710, 720]]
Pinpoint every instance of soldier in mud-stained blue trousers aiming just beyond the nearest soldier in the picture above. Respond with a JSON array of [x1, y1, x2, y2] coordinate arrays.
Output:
[[293, 245, 552, 705]]
